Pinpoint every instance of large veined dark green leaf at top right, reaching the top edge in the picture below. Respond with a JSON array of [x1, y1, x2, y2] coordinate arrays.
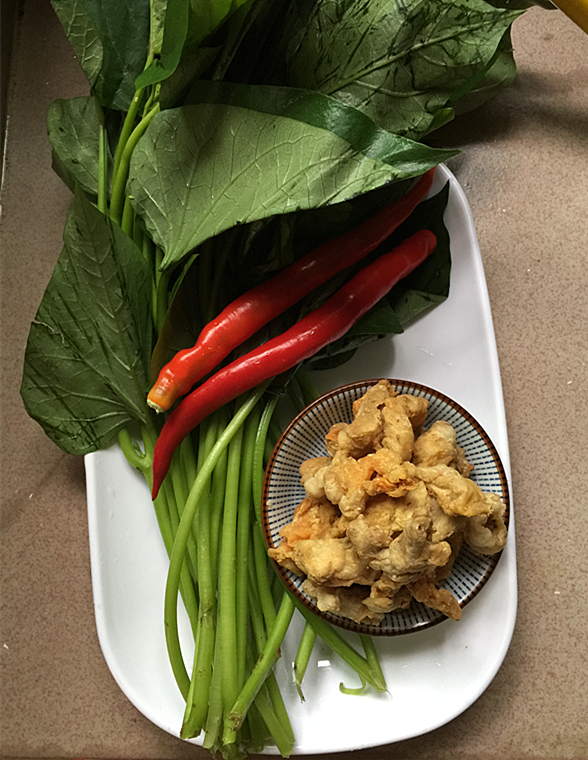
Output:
[[284, 0, 521, 139]]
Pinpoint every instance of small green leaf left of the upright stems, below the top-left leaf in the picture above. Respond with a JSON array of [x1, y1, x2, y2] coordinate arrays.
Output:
[[47, 97, 105, 196]]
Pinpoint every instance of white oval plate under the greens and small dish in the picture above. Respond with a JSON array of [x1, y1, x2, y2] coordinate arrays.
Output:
[[86, 166, 517, 754]]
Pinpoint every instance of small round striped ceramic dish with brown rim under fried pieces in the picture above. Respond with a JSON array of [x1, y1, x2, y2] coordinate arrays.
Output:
[[262, 379, 509, 636]]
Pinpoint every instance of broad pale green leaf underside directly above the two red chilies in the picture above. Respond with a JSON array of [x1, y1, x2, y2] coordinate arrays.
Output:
[[128, 98, 447, 267]]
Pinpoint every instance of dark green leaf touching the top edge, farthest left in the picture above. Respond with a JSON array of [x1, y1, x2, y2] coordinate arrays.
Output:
[[52, 0, 151, 111]]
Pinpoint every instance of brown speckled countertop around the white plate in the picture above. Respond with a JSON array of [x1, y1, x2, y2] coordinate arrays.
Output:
[[0, 0, 588, 760]]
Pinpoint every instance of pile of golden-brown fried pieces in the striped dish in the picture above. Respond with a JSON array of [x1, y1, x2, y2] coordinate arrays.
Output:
[[269, 380, 506, 625]]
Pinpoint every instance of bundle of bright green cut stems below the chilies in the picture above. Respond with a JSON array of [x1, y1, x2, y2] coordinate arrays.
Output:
[[120, 370, 386, 758]]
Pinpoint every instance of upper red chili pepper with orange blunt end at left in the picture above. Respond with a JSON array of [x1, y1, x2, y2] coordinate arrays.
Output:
[[147, 169, 435, 412]]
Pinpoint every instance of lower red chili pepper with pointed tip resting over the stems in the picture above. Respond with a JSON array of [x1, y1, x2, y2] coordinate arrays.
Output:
[[152, 230, 437, 498]]
